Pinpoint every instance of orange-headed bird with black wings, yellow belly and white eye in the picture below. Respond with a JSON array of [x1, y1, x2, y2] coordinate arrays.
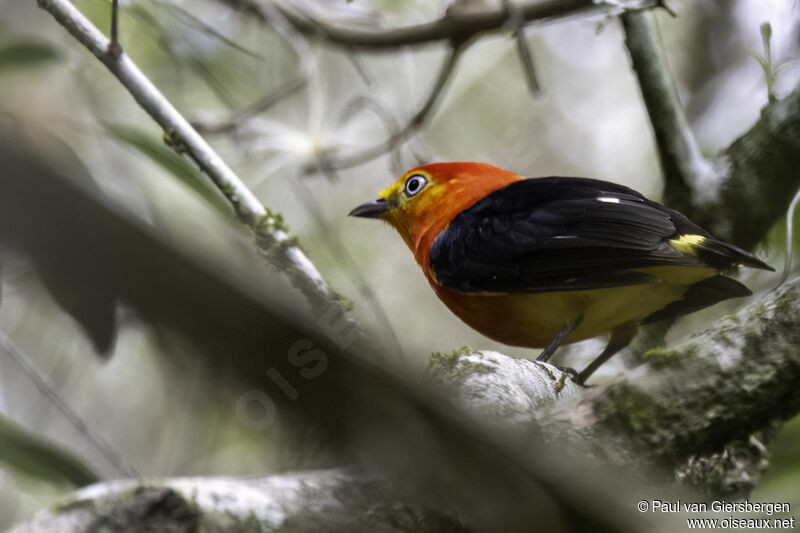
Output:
[[349, 162, 774, 385]]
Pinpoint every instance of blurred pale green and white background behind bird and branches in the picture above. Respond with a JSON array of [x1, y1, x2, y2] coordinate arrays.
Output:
[[0, 0, 800, 529]]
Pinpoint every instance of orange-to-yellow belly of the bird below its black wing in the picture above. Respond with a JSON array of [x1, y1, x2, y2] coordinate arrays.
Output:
[[434, 267, 716, 348]]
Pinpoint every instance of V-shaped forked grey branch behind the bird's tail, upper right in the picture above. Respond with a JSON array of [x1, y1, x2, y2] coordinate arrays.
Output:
[[622, 12, 800, 248]]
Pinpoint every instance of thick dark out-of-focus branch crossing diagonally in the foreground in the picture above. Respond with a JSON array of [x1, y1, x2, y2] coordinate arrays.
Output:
[[0, 140, 642, 532]]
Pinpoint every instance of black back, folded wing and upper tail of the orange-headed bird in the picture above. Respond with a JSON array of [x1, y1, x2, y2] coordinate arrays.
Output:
[[430, 177, 766, 292]]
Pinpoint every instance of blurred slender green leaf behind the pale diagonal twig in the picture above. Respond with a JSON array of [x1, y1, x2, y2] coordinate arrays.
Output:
[[107, 124, 233, 218]]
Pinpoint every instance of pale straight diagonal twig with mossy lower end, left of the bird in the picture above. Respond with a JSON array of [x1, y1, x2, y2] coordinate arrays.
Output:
[[38, 0, 349, 320]]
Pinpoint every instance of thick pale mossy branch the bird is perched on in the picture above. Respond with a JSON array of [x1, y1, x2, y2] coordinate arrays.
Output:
[[429, 280, 800, 495]]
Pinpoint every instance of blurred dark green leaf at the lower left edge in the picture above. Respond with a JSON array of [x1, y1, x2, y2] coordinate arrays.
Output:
[[0, 415, 99, 487]]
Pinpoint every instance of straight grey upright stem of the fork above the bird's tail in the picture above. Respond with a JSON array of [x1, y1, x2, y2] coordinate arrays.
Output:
[[621, 12, 711, 214]]
